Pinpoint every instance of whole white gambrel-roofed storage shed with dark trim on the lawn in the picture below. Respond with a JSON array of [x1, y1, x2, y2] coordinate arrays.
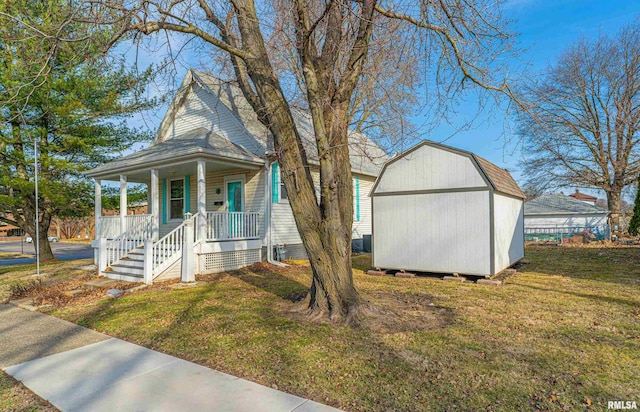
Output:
[[371, 141, 525, 276]]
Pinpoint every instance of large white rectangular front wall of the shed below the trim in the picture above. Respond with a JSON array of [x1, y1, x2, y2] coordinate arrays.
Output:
[[373, 190, 491, 275]]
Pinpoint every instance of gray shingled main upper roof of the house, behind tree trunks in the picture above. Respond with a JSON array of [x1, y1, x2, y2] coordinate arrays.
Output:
[[192, 69, 389, 176]]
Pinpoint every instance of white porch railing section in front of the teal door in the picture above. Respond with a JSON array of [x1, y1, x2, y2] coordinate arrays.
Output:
[[207, 212, 260, 240]]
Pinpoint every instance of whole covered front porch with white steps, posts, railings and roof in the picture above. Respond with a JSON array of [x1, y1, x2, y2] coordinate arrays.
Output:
[[89, 130, 268, 283]]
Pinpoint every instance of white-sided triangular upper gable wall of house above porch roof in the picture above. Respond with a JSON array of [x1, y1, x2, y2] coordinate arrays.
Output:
[[162, 84, 264, 153]]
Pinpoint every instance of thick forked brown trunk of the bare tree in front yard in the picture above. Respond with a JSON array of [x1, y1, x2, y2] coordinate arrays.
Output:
[[233, 0, 374, 322]]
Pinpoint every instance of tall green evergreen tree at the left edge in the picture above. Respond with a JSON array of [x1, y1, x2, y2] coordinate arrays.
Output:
[[0, 0, 150, 261]]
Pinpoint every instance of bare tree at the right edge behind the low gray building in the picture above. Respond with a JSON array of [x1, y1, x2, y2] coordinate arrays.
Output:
[[518, 20, 640, 225]]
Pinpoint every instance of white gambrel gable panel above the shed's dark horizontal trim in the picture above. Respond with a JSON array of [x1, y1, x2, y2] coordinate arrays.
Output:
[[376, 145, 487, 193]]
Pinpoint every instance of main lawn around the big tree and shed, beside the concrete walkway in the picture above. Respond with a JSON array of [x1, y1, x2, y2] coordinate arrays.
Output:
[[26, 247, 640, 411]]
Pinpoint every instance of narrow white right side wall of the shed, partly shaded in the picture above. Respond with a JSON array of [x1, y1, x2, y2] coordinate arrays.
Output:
[[493, 193, 524, 273]]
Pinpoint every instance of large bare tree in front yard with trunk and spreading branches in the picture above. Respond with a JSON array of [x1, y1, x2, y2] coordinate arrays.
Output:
[[72, 0, 511, 321]]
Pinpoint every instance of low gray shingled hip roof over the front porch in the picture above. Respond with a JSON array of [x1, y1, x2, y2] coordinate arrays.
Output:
[[87, 128, 264, 176]]
